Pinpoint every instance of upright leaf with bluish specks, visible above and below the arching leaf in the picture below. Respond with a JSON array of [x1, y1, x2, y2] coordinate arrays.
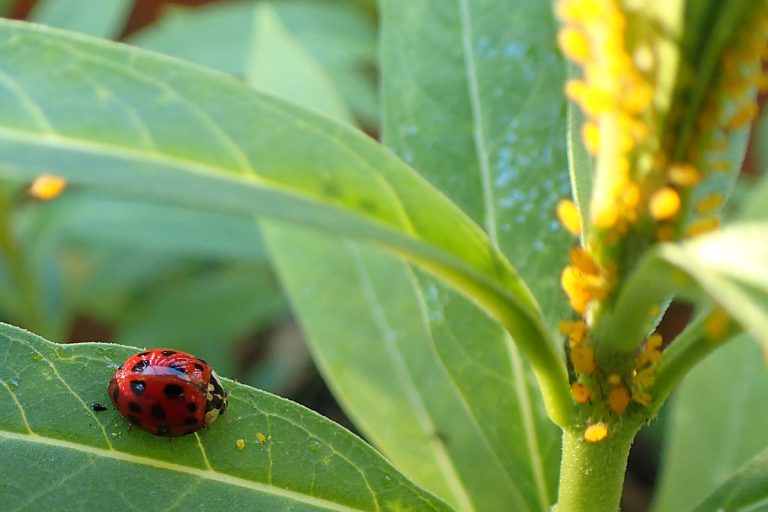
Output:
[[381, 0, 572, 504]]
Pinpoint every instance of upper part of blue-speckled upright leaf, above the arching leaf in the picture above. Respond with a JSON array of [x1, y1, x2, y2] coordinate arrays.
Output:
[[382, 0, 573, 323]]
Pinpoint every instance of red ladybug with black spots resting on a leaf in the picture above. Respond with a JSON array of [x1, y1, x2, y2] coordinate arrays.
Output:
[[109, 348, 227, 437]]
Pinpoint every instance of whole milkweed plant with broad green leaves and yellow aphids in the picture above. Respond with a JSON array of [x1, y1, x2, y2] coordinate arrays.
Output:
[[0, 0, 768, 512]]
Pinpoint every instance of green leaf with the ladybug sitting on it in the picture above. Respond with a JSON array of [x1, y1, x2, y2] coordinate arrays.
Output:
[[0, 324, 449, 511]]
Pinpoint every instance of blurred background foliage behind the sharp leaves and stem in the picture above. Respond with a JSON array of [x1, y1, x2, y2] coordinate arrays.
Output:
[[0, 0, 768, 512]]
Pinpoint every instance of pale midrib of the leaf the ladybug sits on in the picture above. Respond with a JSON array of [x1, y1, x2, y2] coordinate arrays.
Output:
[[0, 430, 364, 512]]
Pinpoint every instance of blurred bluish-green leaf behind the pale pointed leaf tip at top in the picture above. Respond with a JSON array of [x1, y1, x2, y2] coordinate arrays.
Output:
[[128, 0, 379, 126]]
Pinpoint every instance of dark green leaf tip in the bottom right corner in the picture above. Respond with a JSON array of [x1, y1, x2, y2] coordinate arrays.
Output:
[[694, 450, 768, 512]]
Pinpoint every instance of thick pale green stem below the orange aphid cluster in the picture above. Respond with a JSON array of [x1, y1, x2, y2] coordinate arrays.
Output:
[[556, 423, 640, 512]]
